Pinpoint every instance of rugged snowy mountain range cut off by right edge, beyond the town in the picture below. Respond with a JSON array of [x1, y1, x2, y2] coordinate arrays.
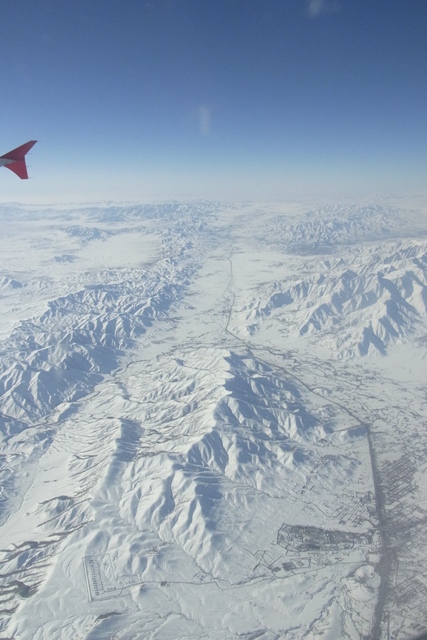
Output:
[[235, 240, 427, 357]]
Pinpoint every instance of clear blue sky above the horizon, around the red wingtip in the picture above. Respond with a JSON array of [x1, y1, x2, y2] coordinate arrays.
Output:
[[0, 0, 427, 202]]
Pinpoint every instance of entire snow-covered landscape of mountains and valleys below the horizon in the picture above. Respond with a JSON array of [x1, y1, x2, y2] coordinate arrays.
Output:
[[0, 201, 427, 640]]
